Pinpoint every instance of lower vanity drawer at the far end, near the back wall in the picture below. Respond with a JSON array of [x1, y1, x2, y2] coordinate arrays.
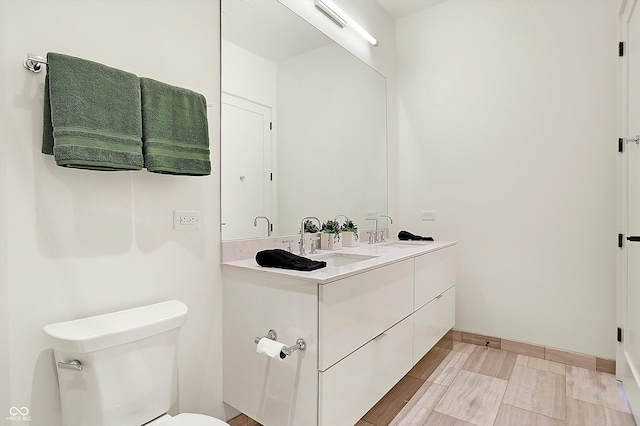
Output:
[[413, 287, 456, 364]]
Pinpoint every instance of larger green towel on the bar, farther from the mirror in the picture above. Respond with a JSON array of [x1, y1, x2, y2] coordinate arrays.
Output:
[[42, 53, 143, 170]]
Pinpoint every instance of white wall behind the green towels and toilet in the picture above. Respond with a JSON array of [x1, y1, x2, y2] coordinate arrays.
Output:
[[0, 0, 223, 426]]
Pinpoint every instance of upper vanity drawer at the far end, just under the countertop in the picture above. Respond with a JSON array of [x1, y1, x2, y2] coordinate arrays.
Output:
[[414, 247, 456, 311]]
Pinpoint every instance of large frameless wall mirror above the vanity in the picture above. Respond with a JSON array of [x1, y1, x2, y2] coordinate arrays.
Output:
[[221, 0, 387, 240]]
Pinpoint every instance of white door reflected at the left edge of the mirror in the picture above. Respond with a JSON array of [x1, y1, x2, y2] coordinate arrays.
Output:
[[221, 93, 275, 239]]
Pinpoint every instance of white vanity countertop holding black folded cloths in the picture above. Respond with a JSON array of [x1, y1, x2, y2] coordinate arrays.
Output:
[[222, 240, 456, 284]]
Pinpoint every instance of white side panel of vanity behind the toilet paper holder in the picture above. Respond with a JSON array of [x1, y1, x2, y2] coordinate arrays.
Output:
[[222, 268, 318, 426]]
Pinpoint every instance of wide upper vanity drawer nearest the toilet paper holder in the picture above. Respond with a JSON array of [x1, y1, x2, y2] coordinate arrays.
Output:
[[318, 259, 414, 371]]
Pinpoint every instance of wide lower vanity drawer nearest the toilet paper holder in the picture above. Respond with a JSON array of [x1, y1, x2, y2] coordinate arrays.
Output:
[[318, 317, 413, 426]]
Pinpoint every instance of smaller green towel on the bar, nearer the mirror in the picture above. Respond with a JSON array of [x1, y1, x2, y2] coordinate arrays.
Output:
[[140, 78, 211, 176]]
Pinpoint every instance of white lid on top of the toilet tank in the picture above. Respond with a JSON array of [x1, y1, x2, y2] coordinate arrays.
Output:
[[44, 300, 188, 353]]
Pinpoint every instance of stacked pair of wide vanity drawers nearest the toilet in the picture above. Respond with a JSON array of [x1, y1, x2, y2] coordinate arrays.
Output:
[[318, 259, 414, 426]]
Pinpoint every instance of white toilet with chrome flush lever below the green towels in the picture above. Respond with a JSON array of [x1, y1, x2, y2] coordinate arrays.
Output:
[[44, 300, 228, 426]]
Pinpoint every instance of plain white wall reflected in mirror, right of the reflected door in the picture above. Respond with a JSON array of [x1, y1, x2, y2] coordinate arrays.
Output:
[[276, 43, 387, 234]]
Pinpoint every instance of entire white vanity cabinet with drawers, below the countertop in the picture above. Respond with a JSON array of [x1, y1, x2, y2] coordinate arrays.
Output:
[[222, 244, 455, 426]]
